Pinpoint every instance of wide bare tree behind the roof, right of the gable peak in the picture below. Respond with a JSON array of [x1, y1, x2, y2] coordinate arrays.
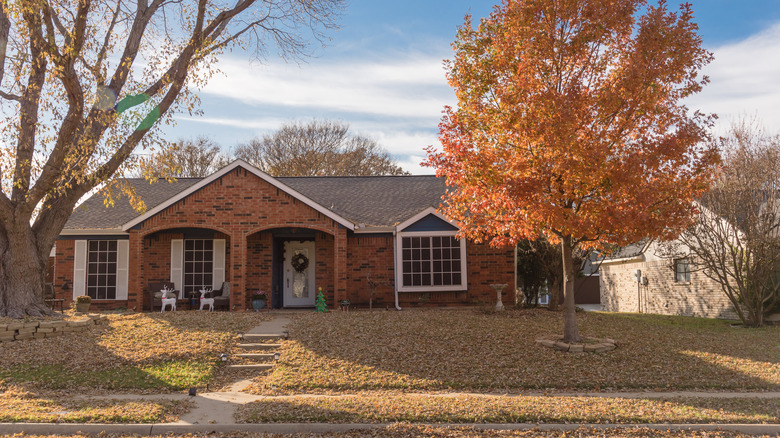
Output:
[[235, 120, 408, 176]]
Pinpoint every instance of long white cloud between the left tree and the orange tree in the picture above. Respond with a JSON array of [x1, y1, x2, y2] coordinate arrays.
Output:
[[203, 55, 453, 122]]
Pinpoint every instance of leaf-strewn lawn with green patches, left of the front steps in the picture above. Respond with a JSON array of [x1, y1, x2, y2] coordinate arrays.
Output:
[[0, 311, 269, 393]]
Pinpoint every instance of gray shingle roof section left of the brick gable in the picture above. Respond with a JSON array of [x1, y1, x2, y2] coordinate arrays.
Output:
[[65, 178, 202, 230]]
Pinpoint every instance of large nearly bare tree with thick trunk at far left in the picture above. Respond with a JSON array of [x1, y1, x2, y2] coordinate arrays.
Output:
[[0, 0, 345, 318]]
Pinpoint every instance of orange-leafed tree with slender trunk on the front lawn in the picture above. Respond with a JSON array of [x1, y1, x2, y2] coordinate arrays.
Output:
[[426, 0, 718, 342]]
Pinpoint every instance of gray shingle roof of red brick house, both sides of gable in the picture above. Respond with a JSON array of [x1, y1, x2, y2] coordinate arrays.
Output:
[[65, 175, 446, 230]]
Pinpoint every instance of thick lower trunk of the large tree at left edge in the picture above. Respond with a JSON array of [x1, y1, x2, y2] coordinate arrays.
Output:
[[0, 221, 54, 318]]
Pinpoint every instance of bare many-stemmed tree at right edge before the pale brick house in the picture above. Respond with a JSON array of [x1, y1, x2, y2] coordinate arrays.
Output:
[[660, 121, 780, 327]]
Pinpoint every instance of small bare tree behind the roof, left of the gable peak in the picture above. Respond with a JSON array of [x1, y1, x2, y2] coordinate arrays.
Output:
[[141, 136, 230, 178]]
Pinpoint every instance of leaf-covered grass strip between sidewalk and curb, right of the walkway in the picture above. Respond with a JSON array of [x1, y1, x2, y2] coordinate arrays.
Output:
[[236, 394, 780, 424]]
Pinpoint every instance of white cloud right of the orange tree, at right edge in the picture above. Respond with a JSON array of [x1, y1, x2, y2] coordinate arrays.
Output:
[[687, 23, 780, 133]]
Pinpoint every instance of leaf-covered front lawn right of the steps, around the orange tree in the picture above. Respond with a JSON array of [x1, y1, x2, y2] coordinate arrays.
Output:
[[248, 310, 780, 395]]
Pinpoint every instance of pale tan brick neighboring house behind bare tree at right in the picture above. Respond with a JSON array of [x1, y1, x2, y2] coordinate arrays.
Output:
[[599, 240, 736, 319]]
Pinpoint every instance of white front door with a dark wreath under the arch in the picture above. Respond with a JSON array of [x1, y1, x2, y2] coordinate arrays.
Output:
[[282, 241, 316, 307]]
